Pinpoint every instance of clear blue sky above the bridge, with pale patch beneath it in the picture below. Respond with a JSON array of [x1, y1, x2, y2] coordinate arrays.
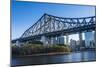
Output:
[[11, 0, 95, 40]]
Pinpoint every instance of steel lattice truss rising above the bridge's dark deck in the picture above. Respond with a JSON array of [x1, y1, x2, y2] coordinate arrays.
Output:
[[21, 14, 96, 38]]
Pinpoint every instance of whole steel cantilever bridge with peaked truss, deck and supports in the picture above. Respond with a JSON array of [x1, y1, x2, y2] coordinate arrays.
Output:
[[12, 13, 96, 44]]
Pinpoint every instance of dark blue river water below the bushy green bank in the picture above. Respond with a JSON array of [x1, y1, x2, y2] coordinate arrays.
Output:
[[11, 51, 96, 66]]
